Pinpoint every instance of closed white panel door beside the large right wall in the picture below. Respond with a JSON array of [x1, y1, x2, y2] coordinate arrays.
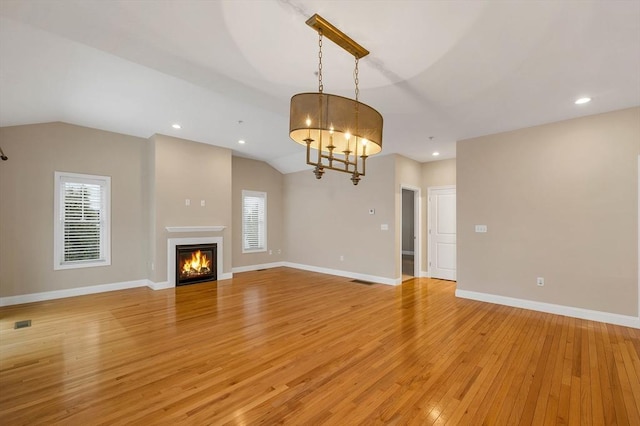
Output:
[[429, 187, 456, 281]]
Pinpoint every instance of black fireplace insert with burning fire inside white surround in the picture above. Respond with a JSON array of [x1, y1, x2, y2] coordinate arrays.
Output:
[[176, 243, 218, 286]]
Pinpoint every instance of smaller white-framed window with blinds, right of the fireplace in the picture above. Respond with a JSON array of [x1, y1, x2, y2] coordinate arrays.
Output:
[[242, 191, 267, 253]]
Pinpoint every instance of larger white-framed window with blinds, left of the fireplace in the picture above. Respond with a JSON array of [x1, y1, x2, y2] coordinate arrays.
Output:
[[53, 172, 111, 269]]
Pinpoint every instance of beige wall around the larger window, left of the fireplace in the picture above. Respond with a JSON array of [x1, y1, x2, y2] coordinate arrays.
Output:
[[0, 123, 146, 297]]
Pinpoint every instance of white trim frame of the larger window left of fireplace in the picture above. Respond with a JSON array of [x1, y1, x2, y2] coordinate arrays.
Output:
[[53, 172, 111, 270]]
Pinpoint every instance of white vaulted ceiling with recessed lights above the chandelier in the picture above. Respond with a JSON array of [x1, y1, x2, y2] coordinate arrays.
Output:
[[0, 0, 640, 173]]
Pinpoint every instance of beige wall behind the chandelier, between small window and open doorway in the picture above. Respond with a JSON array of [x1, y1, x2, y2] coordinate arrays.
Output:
[[284, 155, 400, 279]]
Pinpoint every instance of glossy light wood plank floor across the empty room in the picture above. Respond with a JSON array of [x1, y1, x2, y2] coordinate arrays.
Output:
[[0, 268, 640, 425]]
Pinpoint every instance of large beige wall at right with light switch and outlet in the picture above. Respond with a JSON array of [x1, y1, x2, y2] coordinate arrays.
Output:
[[457, 108, 640, 316]]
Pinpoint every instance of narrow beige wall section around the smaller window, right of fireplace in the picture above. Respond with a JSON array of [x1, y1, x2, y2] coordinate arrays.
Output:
[[232, 157, 285, 268]]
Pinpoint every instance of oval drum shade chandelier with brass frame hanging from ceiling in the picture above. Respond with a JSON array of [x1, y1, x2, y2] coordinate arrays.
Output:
[[289, 14, 382, 185]]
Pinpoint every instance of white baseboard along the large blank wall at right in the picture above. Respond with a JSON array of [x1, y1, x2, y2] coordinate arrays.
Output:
[[456, 289, 640, 328]]
